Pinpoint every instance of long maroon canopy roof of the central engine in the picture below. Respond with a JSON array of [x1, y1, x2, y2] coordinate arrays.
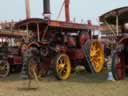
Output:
[[15, 18, 100, 30]]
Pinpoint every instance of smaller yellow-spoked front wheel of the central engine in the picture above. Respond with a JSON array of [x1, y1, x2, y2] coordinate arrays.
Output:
[[56, 54, 71, 80]]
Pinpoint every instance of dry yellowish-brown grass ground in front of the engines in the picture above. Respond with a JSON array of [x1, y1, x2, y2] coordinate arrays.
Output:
[[0, 72, 128, 96]]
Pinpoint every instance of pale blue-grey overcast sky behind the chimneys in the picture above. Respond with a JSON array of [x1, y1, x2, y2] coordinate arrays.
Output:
[[0, 0, 128, 24]]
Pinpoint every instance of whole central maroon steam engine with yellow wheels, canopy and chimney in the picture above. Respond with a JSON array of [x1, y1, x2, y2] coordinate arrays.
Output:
[[15, 0, 104, 80]]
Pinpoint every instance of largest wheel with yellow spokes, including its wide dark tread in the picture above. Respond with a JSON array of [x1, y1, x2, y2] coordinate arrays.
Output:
[[83, 40, 104, 73]]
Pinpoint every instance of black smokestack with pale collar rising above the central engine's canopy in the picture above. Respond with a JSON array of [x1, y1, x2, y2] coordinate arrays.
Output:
[[43, 0, 51, 19]]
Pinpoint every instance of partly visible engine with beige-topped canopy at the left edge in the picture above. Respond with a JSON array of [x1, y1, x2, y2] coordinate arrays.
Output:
[[0, 22, 26, 78]]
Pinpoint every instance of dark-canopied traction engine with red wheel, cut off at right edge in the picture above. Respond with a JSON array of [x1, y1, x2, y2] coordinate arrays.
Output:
[[100, 7, 128, 80]]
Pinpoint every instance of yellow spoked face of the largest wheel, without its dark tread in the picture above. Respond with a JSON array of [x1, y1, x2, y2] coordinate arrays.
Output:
[[89, 41, 104, 72]]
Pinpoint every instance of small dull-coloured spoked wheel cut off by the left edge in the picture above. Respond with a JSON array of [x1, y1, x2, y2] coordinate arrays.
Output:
[[0, 61, 10, 78]]
